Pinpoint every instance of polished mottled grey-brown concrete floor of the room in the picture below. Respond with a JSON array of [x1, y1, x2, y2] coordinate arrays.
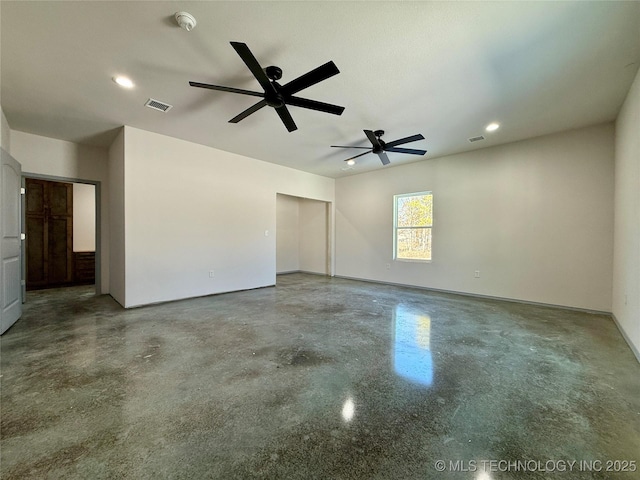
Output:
[[0, 274, 640, 480]]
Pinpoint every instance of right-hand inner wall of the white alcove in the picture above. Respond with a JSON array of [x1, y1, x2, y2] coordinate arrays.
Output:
[[300, 198, 329, 275]]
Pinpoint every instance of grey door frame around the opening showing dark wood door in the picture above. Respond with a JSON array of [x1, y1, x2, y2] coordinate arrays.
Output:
[[21, 172, 102, 303]]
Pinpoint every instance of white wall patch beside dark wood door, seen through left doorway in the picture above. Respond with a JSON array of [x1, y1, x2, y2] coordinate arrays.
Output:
[[73, 183, 96, 252]]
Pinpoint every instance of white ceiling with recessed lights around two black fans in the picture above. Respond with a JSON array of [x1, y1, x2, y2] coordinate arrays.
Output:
[[0, 0, 640, 177]]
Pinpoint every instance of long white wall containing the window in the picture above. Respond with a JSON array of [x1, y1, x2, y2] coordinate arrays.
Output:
[[335, 124, 614, 311]]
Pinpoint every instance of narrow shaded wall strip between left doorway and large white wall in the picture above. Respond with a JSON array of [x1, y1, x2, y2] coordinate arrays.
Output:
[[109, 128, 126, 305]]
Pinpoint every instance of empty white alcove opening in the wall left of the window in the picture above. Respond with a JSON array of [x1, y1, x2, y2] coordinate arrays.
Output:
[[276, 193, 331, 275]]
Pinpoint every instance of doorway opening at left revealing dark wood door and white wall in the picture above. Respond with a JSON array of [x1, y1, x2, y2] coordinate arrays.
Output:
[[22, 175, 100, 299]]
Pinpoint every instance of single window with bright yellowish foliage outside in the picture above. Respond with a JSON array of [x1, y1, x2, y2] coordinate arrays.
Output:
[[393, 192, 433, 261]]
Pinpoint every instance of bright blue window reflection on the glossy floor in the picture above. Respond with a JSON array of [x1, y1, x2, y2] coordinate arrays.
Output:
[[393, 304, 433, 386]]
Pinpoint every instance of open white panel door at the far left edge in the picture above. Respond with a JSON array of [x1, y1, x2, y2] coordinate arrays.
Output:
[[0, 149, 22, 334]]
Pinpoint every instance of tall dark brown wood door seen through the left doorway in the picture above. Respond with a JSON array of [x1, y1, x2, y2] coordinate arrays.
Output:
[[26, 178, 73, 290]]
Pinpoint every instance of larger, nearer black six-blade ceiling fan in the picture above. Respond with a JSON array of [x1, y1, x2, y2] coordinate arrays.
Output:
[[189, 42, 344, 132]]
